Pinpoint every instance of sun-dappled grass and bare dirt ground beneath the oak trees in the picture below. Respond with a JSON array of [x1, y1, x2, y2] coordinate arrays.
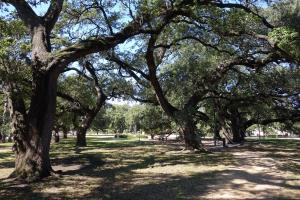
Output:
[[0, 136, 300, 200]]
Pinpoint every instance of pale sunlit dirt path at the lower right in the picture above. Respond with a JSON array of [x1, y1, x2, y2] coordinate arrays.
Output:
[[204, 145, 300, 199]]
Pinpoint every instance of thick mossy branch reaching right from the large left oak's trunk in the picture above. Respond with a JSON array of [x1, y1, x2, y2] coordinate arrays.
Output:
[[53, 9, 190, 69]]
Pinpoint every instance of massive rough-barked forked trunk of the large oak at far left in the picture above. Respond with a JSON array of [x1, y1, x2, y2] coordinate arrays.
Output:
[[1, 0, 63, 181]]
